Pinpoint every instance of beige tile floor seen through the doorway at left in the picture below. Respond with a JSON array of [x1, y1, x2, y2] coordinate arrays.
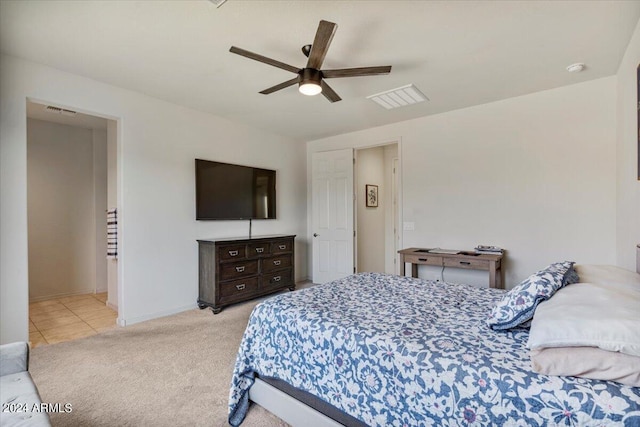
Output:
[[29, 293, 118, 348]]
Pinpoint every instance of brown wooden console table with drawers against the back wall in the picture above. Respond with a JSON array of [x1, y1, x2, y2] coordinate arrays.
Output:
[[398, 248, 504, 289]]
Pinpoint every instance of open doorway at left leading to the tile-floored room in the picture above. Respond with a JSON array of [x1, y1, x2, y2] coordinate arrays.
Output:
[[26, 101, 118, 346]]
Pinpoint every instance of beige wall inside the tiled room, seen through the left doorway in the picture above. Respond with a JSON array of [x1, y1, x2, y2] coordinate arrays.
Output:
[[27, 119, 106, 301]]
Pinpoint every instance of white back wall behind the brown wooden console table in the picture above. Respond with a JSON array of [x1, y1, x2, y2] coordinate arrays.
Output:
[[307, 77, 616, 288]]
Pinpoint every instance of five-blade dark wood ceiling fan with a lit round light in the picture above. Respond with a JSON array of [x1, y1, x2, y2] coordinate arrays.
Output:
[[229, 21, 391, 102]]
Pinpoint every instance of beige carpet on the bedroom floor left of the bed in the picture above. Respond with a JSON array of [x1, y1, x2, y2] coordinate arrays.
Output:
[[29, 302, 286, 427]]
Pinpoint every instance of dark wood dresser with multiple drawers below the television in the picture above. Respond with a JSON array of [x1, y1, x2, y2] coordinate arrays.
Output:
[[198, 235, 296, 314]]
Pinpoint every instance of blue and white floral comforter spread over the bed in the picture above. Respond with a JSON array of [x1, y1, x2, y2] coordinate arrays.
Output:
[[229, 273, 640, 426]]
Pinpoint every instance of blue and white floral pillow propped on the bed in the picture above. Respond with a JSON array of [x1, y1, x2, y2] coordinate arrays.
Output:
[[487, 261, 578, 330]]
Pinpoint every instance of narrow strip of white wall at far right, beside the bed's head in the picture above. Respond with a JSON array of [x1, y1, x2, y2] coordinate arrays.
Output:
[[617, 22, 640, 271]]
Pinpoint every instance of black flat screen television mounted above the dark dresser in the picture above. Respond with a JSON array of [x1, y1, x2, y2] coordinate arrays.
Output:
[[196, 159, 276, 220]]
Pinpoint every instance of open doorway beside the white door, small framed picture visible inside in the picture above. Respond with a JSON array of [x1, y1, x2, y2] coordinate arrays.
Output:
[[354, 143, 400, 274]]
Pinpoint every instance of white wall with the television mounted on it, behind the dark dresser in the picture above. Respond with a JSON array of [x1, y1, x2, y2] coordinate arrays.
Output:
[[0, 55, 308, 343]]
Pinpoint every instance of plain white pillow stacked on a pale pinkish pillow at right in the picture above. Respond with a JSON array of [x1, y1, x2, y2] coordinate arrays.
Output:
[[528, 267, 640, 356]]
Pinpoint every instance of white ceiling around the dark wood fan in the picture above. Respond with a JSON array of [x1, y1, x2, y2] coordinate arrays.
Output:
[[0, 0, 640, 141]]
